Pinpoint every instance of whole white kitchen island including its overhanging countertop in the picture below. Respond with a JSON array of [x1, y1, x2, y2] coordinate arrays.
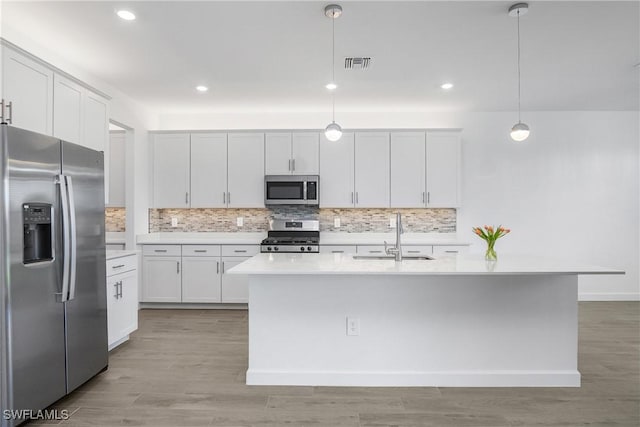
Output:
[[229, 254, 624, 387]]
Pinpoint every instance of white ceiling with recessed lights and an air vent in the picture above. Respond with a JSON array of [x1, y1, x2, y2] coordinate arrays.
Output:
[[2, 1, 640, 113]]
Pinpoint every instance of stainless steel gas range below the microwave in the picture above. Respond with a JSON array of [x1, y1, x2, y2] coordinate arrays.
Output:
[[260, 219, 320, 253]]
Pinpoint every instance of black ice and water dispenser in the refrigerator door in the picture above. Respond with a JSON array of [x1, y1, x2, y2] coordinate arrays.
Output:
[[22, 203, 53, 264]]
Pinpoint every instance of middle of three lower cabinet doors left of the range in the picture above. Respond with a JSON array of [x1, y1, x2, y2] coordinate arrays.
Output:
[[182, 257, 220, 302]]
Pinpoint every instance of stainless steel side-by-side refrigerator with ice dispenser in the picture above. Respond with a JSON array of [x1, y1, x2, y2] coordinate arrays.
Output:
[[0, 124, 108, 426]]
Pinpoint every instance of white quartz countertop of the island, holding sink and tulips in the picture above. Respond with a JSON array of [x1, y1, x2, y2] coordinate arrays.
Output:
[[227, 254, 624, 276]]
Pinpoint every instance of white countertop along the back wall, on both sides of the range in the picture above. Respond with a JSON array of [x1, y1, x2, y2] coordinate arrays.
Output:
[[137, 232, 470, 245]]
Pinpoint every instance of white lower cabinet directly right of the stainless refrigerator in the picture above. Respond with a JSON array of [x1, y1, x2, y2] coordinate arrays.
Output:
[[107, 255, 138, 350]]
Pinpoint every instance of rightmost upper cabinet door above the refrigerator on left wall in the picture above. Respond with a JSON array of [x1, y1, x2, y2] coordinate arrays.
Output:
[[81, 91, 109, 153]]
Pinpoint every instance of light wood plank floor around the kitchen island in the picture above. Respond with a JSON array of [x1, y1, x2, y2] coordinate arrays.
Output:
[[40, 302, 640, 427]]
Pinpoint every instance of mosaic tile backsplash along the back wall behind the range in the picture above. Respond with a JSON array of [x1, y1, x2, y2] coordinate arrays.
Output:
[[149, 206, 456, 233]]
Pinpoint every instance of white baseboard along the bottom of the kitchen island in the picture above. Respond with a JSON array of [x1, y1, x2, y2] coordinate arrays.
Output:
[[247, 369, 580, 387]]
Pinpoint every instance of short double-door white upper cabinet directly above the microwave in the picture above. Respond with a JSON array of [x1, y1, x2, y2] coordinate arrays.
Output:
[[265, 132, 320, 175]]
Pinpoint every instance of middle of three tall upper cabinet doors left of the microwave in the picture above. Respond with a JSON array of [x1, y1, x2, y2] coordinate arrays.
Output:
[[191, 133, 227, 208]]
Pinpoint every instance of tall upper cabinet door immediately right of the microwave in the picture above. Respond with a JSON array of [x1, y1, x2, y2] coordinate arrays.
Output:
[[320, 133, 355, 208]]
